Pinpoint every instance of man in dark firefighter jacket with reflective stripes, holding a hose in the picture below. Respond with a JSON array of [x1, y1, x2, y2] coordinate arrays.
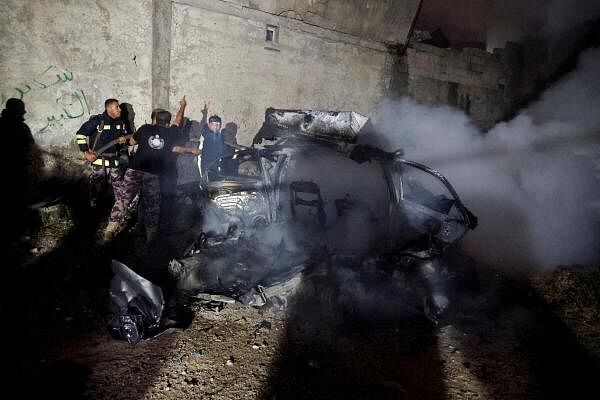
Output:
[[75, 98, 126, 232]]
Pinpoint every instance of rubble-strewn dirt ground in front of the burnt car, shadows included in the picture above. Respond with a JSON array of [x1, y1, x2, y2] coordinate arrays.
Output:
[[0, 152, 600, 399]]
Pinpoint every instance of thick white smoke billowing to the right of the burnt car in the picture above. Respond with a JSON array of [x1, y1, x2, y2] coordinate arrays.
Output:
[[374, 49, 600, 267]]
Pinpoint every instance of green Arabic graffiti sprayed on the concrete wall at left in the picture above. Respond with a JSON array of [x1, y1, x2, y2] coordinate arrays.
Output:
[[0, 65, 90, 133]]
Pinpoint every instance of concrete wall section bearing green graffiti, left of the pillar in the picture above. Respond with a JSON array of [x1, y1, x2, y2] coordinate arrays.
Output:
[[0, 0, 152, 146]]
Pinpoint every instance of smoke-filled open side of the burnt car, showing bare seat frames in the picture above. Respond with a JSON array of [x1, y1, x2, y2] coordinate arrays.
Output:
[[281, 148, 389, 251]]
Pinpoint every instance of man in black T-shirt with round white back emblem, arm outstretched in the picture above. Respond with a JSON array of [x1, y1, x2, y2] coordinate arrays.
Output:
[[106, 111, 200, 243]]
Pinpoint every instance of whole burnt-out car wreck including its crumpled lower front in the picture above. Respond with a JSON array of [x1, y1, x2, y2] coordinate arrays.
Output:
[[110, 109, 477, 344]]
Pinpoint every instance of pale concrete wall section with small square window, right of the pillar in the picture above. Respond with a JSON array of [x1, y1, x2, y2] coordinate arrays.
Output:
[[170, 1, 392, 144]]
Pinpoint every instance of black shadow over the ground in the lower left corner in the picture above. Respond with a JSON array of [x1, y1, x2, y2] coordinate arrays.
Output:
[[0, 167, 202, 398]]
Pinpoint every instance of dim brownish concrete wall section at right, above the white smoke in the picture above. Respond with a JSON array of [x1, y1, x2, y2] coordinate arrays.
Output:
[[395, 43, 511, 130]]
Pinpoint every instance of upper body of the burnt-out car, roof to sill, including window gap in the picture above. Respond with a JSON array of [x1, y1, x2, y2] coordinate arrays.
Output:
[[202, 109, 477, 250]]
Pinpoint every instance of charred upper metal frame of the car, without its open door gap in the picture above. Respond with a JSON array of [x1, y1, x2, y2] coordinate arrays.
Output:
[[201, 108, 477, 255]]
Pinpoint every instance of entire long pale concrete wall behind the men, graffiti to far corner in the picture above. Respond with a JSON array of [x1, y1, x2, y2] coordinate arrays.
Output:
[[0, 0, 419, 146]]
